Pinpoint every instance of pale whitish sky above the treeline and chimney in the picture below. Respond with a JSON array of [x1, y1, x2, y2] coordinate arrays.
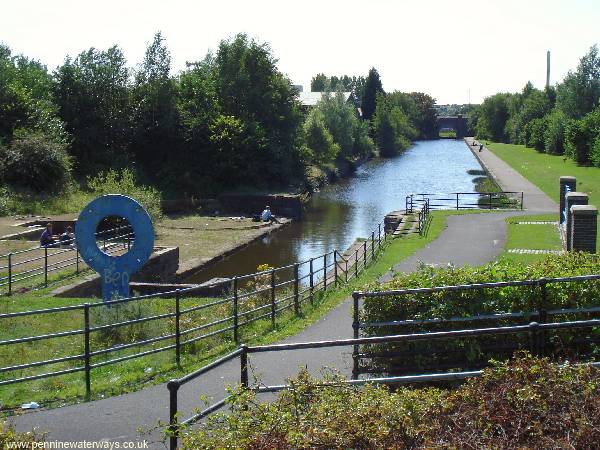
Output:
[[0, 0, 600, 104]]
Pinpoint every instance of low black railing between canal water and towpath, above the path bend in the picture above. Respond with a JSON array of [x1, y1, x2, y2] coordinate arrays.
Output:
[[405, 191, 523, 213]]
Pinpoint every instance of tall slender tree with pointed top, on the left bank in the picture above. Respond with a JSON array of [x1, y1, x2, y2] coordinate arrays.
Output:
[[131, 32, 181, 179]]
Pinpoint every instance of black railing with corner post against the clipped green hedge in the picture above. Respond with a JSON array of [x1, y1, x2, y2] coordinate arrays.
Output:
[[352, 275, 600, 377]]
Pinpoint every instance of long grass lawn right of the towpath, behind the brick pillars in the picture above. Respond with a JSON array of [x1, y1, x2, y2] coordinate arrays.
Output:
[[485, 142, 600, 249]]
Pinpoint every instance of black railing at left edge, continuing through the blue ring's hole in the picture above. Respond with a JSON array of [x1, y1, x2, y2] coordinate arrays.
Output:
[[0, 225, 135, 295]]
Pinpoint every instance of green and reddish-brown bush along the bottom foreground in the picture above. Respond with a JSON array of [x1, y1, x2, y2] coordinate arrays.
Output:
[[182, 355, 600, 450]]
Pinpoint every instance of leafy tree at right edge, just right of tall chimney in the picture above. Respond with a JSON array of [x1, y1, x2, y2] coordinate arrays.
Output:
[[556, 45, 600, 119]]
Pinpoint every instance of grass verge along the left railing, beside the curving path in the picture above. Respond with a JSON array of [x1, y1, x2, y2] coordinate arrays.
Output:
[[0, 211, 464, 408]]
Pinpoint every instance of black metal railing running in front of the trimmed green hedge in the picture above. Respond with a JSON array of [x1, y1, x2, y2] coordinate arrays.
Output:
[[352, 275, 600, 378]]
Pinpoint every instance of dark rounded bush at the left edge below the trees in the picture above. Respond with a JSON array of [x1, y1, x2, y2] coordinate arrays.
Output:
[[0, 133, 71, 192]]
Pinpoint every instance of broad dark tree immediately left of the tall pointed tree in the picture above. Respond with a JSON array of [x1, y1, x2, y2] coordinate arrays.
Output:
[[54, 46, 132, 175]]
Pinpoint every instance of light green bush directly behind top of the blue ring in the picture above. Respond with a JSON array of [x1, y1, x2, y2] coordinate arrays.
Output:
[[87, 169, 162, 224]]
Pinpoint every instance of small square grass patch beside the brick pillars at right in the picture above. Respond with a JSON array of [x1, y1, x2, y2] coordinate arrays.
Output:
[[501, 214, 562, 264]]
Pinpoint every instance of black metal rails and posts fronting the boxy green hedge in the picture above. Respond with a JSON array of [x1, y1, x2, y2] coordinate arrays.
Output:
[[352, 275, 600, 377]]
